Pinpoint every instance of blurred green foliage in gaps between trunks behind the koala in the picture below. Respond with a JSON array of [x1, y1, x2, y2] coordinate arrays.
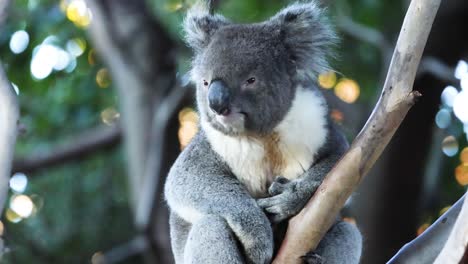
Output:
[[0, 0, 466, 263]]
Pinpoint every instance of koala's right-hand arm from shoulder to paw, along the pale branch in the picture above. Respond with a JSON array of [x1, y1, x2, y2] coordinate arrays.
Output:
[[257, 125, 348, 223]]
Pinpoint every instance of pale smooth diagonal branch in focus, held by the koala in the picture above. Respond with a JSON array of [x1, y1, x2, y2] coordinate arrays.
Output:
[[273, 0, 440, 263]]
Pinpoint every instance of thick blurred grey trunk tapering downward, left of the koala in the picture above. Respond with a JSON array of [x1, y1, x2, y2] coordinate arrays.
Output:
[[87, 0, 175, 208]]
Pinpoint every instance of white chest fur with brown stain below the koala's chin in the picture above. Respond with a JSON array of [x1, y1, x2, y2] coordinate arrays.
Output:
[[202, 87, 327, 197]]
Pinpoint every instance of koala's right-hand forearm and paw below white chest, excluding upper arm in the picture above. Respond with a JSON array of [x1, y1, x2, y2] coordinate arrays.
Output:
[[257, 155, 340, 223]]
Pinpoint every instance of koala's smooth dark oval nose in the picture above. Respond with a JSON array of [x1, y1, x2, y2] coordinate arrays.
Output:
[[208, 80, 231, 116]]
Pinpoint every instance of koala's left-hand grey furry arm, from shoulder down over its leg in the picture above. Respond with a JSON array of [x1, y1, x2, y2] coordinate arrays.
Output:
[[165, 134, 273, 263]]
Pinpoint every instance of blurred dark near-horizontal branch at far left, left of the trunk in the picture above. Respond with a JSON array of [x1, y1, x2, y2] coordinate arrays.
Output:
[[13, 126, 122, 173]]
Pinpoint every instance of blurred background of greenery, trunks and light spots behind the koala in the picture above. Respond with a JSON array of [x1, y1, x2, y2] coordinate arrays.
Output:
[[0, 0, 468, 264]]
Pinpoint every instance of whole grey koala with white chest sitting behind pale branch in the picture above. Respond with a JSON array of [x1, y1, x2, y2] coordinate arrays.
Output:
[[165, 1, 362, 264]]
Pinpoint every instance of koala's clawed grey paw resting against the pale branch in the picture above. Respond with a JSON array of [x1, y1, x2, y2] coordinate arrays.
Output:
[[257, 177, 319, 223]]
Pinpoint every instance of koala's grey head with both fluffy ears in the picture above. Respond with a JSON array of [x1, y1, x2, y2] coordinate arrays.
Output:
[[184, 2, 336, 136]]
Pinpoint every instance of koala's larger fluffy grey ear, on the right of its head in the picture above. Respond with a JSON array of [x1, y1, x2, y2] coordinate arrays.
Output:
[[267, 1, 338, 76]]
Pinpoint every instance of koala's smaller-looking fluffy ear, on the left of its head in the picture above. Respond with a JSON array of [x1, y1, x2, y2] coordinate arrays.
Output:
[[183, 1, 229, 52]]
